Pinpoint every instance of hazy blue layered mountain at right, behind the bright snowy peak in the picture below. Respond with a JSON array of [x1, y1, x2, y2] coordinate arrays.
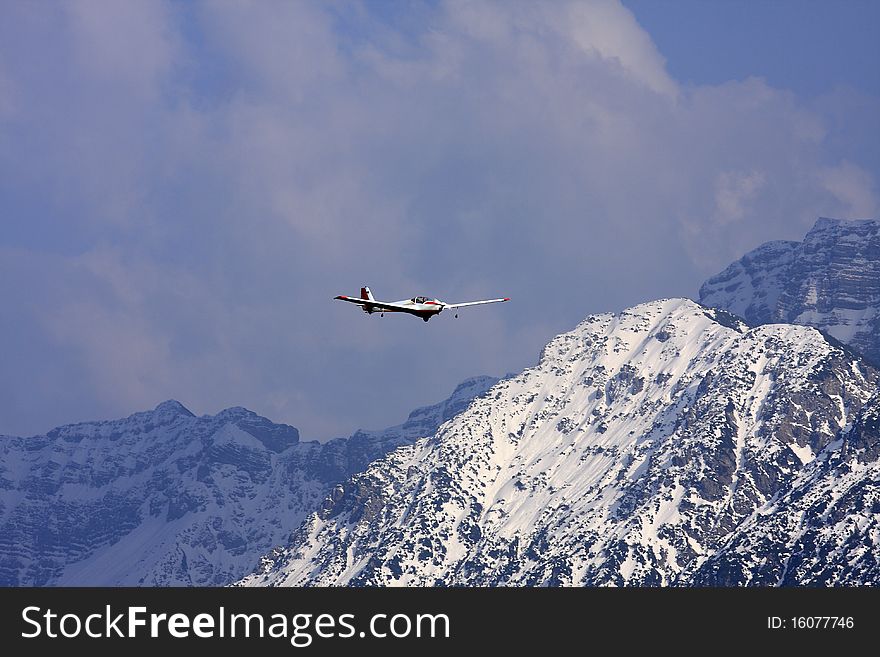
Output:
[[700, 218, 880, 363]]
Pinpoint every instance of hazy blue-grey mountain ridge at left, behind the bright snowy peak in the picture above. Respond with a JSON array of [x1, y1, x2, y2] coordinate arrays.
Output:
[[0, 377, 497, 586]]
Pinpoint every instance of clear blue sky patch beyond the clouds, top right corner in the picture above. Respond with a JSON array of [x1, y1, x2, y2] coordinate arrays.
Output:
[[624, 0, 880, 98]]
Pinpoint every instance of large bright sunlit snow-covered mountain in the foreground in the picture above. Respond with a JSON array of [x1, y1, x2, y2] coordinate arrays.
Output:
[[241, 299, 880, 586]]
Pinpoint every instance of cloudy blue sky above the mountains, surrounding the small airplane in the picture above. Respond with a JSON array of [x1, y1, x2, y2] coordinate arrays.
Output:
[[0, 0, 880, 440]]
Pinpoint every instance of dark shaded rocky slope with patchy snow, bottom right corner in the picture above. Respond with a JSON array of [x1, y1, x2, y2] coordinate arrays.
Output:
[[693, 395, 880, 586]]
